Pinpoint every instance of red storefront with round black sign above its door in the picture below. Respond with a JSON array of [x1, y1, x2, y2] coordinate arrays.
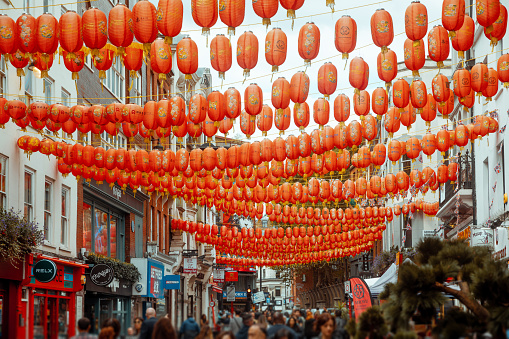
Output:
[[20, 254, 88, 339]]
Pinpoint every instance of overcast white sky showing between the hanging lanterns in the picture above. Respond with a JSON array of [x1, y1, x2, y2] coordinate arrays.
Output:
[[150, 0, 442, 141]]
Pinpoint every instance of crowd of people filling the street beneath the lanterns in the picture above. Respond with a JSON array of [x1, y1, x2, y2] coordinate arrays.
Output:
[[69, 308, 349, 339]]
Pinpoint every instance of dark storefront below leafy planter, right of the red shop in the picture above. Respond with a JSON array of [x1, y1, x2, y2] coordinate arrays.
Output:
[[84, 276, 132, 335]]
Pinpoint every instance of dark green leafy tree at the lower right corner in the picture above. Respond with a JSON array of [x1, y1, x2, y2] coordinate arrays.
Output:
[[380, 238, 509, 338]]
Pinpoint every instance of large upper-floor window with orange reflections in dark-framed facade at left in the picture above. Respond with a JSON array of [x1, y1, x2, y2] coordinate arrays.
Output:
[[83, 203, 123, 260]]
